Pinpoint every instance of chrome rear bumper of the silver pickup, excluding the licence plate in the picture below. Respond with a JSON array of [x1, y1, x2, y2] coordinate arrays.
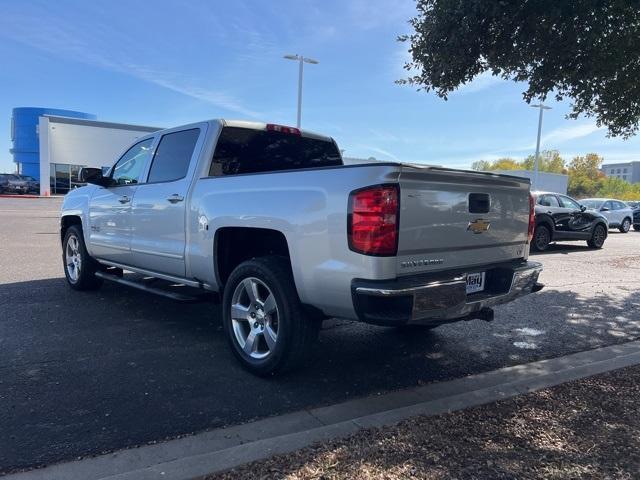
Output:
[[352, 261, 542, 325]]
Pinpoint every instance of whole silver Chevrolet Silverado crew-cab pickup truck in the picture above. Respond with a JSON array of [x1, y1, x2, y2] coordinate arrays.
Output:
[[60, 120, 542, 375]]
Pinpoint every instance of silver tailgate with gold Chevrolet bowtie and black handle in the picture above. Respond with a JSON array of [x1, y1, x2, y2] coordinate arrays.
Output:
[[397, 165, 530, 275]]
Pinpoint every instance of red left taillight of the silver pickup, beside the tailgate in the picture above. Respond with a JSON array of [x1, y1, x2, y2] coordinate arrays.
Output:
[[347, 185, 400, 256]]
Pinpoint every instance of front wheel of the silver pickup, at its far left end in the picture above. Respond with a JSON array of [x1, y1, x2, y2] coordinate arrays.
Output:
[[62, 225, 102, 290]]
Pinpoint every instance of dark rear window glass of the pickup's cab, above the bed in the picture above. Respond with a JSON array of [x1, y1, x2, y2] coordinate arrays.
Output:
[[209, 127, 342, 176]]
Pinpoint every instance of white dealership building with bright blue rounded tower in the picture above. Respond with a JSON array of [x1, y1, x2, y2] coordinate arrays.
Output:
[[11, 107, 160, 196]]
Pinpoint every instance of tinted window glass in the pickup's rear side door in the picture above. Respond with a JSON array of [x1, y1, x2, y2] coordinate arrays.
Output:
[[147, 128, 200, 183]]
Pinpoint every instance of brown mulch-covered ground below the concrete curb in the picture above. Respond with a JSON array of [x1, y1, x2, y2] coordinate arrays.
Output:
[[208, 367, 640, 480]]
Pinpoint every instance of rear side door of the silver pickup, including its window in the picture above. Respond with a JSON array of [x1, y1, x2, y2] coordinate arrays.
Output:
[[131, 124, 206, 277]]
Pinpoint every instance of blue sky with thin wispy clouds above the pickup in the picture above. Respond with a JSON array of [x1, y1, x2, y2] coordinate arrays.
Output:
[[0, 0, 640, 171]]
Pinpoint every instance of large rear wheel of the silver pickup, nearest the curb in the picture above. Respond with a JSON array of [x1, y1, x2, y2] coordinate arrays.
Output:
[[222, 256, 320, 376]]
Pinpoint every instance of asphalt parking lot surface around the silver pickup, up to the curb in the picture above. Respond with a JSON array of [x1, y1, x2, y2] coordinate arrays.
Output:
[[0, 199, 640, 472]]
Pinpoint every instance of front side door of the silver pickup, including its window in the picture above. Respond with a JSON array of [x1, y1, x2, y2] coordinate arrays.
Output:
[[88, 137, 154, 264]]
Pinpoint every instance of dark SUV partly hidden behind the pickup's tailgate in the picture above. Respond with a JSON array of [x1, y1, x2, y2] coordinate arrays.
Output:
[[531, 192, 609, 251]]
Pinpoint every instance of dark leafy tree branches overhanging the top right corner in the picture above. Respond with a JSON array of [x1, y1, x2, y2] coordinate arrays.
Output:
[[398, 0, 640, 137]]
